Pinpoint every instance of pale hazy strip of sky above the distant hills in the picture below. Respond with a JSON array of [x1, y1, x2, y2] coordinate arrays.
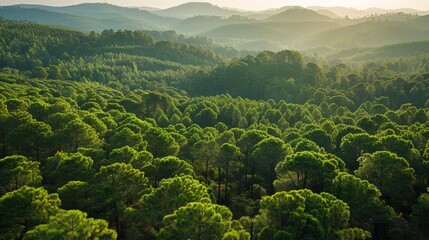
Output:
[[0, 0, 429, 10]]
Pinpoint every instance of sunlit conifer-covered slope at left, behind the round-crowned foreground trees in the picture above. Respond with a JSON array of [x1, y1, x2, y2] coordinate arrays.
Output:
[[0, 21, 223, 87]]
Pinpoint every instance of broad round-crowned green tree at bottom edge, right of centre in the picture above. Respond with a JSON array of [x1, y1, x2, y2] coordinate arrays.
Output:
[[257, 190, 360, 239]]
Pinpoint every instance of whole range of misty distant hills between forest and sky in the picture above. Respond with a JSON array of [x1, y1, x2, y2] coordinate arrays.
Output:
[[0, 2, 429, 52]]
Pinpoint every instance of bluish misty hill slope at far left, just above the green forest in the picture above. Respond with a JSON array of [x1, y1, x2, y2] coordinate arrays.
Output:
[[0, 3, 177, 31]]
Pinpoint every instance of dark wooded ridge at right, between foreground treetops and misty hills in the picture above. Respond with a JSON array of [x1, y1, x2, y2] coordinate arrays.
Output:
[[184, 50, 429, 110]]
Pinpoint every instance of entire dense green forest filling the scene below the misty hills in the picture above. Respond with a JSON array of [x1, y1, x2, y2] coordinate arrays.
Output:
[[0, 17, 429, 240]]
